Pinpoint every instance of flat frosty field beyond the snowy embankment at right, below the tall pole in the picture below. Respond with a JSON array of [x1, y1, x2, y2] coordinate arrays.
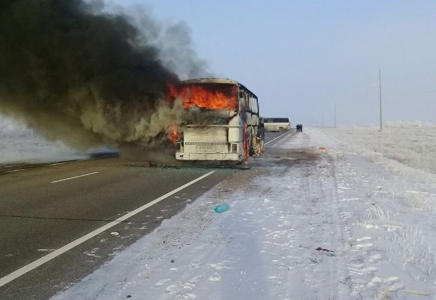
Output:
[[319, 123, 436, 177]]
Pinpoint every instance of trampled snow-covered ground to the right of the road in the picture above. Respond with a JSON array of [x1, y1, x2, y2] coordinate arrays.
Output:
[[54, 128, 436, 300]]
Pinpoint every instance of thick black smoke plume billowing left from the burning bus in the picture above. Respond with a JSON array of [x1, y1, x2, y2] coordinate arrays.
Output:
[[0, 0, 209, 148]]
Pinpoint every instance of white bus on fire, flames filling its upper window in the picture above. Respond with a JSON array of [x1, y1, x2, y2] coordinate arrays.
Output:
[[167, 78, 263, 162]]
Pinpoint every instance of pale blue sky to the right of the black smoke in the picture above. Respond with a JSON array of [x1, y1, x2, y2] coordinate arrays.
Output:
[[114, 0, 436, 126]]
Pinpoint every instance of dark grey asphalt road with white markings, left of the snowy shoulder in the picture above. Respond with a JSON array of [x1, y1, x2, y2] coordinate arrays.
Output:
[[0, 133, 292, 300]]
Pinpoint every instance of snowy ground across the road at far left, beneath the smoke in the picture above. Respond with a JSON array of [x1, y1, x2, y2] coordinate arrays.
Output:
[[0, 117, 89, 164]]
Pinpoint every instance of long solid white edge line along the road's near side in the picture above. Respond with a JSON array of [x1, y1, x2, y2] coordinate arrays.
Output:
[[0, 171, 215, 287]]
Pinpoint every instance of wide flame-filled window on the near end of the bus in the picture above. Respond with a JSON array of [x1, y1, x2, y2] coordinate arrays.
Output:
[[178, 83, 238, 110]]
